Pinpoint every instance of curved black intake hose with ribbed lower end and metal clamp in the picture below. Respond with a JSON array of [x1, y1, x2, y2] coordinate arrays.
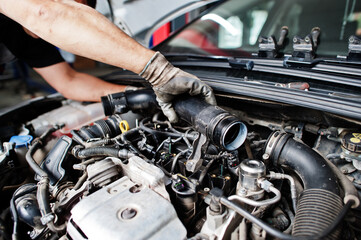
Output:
[[265, 132, 342, 239]]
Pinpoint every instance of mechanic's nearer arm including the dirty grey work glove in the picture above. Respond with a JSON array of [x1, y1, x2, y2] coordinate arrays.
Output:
[[0, 0, 216, 122]]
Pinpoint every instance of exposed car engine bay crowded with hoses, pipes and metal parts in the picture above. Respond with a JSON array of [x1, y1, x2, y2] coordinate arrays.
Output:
[[0, 89, 361, 240]]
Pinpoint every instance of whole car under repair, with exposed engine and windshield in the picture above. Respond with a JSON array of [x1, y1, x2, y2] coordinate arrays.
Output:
[[0, 0, 361, 240]]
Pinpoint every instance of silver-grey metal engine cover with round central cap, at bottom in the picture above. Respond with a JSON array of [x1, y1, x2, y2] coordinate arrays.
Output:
[[67, 176, 187, 240]]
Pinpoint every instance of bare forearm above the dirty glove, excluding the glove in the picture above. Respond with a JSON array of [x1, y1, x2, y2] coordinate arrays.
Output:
[[0, 0, 154, 73]]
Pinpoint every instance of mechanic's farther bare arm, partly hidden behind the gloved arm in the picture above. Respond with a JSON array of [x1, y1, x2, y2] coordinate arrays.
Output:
[[34, 62, 126, 102]]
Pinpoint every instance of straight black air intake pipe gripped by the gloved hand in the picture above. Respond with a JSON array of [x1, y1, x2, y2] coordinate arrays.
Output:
[[102, 90, 247, 151]]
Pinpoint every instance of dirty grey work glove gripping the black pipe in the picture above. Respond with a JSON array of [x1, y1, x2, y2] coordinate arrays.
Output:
[[139, 52, 216, 123]]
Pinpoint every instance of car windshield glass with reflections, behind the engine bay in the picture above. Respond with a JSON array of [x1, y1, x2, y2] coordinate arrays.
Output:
[[158, 0, 361, 57]]
